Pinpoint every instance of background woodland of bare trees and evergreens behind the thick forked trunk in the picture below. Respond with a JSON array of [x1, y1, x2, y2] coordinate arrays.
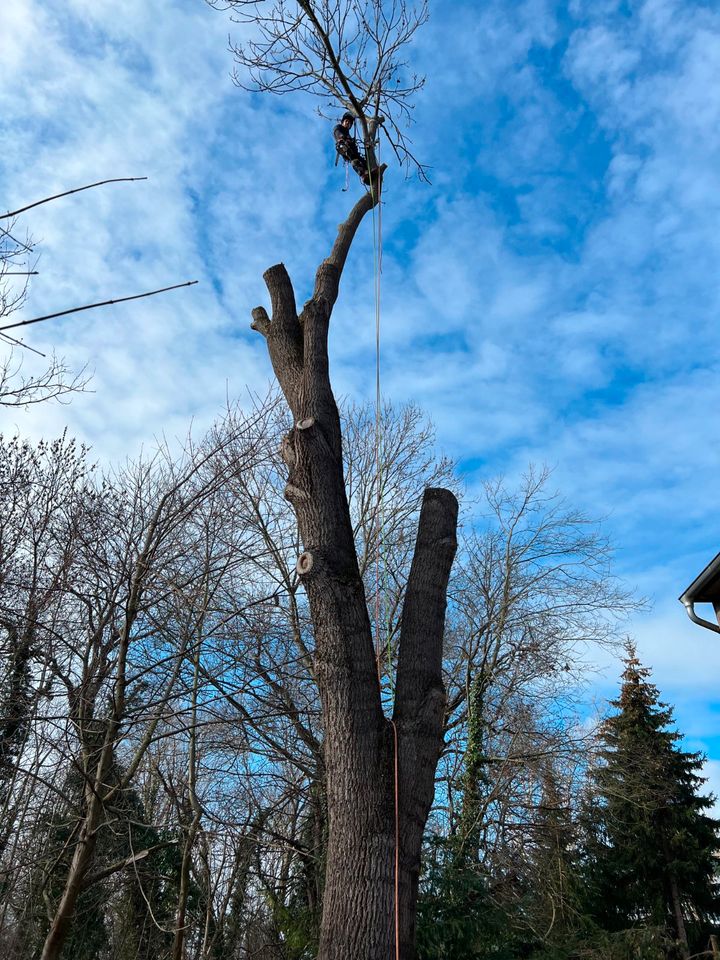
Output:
[[0, 397, 720, 960]]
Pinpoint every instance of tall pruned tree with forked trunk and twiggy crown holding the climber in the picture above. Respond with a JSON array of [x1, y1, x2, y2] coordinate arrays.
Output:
[[204, 0, 450, 960]]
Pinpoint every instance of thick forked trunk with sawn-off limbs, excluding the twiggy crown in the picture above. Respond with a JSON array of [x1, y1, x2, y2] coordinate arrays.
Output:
[[253, 176, 457, 960]]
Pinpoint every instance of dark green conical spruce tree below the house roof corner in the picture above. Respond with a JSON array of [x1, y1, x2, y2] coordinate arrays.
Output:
[[587, 644, 720, 956]]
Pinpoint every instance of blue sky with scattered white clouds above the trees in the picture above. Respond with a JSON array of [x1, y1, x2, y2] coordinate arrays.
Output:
[[0, 0, 720, 789]]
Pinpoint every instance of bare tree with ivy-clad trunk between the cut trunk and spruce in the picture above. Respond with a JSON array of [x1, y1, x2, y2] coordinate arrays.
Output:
[[446, 469, 638, 851]]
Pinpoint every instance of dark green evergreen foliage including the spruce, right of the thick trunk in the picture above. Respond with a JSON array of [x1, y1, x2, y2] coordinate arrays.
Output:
[[418, 649, 720, 960]]
